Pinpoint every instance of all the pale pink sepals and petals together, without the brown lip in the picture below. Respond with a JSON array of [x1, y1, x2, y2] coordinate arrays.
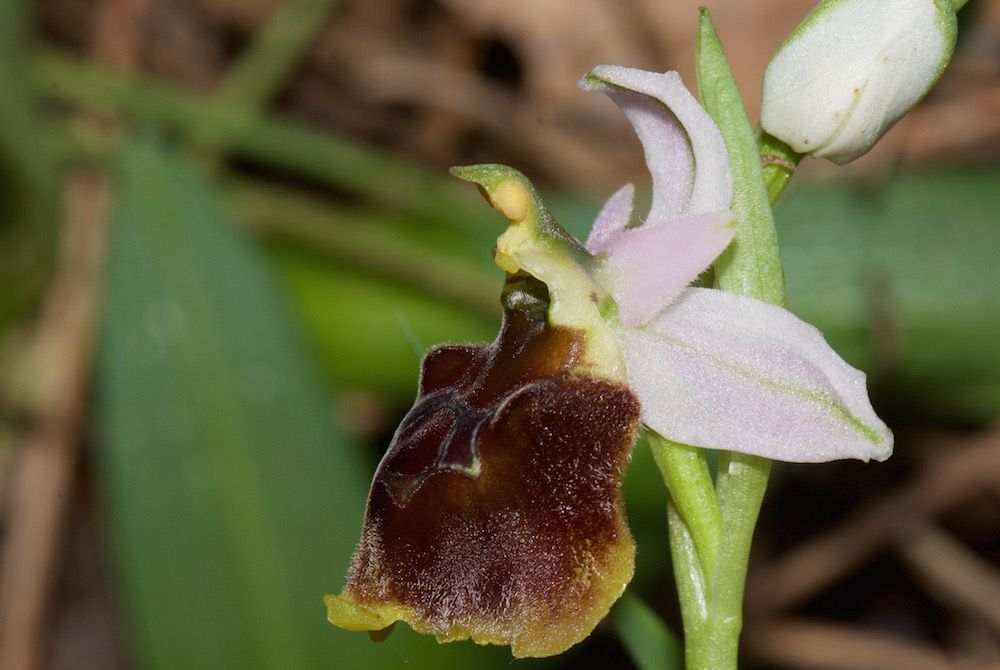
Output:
[[582, 66, 892, 462]]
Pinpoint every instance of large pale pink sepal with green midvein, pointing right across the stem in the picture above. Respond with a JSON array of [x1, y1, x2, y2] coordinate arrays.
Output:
[[618, 288, 892, 463]]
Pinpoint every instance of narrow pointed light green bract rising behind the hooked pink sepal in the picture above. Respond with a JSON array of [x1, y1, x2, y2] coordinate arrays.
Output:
[[695, 7, 784, 305]]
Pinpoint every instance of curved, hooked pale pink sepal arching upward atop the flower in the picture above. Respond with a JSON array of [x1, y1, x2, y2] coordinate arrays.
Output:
[[580, 65, 733, 222]]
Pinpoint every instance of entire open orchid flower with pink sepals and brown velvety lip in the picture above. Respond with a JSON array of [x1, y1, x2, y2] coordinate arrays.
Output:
[[326, 66, 892, 656]]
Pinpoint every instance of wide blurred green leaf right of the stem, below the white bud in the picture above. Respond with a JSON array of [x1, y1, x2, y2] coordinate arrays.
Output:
[[776, 168, 1000, 421]]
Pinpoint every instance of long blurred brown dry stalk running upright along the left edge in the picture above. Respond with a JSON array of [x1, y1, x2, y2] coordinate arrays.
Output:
[[0, 0, 145, 670]]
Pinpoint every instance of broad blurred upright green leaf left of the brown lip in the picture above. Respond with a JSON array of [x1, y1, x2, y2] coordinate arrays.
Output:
[[96, 139, 534, 670]]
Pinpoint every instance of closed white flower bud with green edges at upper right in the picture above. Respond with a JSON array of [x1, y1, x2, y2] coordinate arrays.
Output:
[[761, 0, 958, 164]]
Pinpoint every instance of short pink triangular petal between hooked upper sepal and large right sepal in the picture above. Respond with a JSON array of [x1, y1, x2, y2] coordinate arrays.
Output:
[[604, 212, 736, 326]]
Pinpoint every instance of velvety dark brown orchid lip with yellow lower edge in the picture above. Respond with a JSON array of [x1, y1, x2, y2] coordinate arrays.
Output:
[[341, 292, 639, 656]]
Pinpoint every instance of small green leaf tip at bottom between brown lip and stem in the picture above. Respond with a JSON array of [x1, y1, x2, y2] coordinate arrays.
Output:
[[611, 593, 684, 670]]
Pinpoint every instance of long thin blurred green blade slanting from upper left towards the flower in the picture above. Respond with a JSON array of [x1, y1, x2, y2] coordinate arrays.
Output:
[[35, 51, 483, 230]]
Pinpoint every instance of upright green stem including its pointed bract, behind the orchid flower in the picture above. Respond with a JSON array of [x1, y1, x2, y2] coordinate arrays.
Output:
[[651, 9, 800, 670]]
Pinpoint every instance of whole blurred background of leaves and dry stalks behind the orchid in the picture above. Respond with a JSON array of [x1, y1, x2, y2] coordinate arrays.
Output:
[[0, 0, 1000, 670]]
